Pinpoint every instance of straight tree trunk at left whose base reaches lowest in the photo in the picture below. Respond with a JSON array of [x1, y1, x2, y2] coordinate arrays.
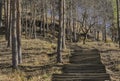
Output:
[[12, 0, 18, 69]]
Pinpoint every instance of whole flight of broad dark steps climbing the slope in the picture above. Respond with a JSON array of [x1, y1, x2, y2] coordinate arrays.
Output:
[[52, 49, 111, 81]]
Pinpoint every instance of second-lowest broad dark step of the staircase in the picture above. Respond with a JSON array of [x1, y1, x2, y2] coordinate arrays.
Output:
[[62, 64, 106, 73]]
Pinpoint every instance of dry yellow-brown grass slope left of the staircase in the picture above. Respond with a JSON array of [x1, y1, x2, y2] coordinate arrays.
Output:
[[0, 36, 63, 81]]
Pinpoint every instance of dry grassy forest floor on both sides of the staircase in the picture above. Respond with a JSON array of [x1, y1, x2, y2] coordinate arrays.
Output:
[[0, 36, 120, 81]]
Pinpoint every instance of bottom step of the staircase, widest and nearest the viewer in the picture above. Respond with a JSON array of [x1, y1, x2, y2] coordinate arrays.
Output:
[[52, 73, 110, 81]]
